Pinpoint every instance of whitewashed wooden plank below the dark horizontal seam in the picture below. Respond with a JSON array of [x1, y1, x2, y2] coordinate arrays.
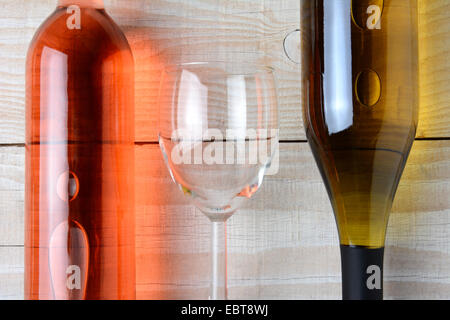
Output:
[[0, 141, 450, 299]]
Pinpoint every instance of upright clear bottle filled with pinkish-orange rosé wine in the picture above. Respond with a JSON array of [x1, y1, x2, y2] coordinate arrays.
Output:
[[25, 0, 135, 300]]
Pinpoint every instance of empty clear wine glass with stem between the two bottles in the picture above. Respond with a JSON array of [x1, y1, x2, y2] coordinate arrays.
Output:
[[159, 62, 278, 300]]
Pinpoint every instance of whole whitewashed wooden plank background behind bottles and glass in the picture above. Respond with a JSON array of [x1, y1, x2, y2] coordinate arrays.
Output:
[[0, 0, 450, 299]]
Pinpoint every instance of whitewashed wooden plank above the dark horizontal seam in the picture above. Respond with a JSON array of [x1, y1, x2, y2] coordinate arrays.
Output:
[[0, 0, 450, 144]]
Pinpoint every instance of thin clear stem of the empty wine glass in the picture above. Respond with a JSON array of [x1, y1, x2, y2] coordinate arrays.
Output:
[[210, 221, 227, 300]]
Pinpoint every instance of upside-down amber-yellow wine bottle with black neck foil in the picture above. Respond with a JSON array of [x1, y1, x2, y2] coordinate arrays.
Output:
[[301, 0, 418, 300]]
